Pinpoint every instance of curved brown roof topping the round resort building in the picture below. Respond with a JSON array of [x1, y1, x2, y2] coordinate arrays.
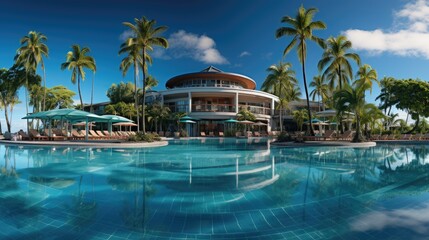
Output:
[[165, 66, 256, 90]]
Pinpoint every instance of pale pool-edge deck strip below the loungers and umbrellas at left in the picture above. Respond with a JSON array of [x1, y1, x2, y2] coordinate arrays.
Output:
[[0, 139, 168, 148]]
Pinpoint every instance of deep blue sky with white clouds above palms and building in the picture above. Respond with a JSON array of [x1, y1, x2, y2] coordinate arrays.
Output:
[[0, 0, 429, 131]]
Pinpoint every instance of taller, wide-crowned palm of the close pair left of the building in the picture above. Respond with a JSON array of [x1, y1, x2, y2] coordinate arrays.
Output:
[[123, 16, 168, 133]]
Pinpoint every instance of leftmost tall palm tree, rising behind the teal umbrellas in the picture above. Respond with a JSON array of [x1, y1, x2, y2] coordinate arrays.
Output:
[[15, 31, 49, 111]]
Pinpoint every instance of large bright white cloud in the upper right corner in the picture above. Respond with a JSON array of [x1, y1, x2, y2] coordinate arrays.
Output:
[[344, 0, 429, 59]]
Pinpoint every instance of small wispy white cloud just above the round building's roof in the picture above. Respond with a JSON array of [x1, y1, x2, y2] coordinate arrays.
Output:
[[154, 30, 228, 64]]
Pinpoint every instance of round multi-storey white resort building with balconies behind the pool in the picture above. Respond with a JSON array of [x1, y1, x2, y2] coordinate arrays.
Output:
[[147, 66, 279, 136]]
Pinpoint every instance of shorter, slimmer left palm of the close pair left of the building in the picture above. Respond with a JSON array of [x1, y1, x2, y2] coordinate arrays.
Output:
[[119, 38, 143, 131]]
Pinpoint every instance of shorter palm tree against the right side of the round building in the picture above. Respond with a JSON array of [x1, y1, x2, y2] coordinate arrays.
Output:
[[261, 62, 298, 132]]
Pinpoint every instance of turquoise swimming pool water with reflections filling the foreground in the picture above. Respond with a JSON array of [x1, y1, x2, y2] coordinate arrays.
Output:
[[0, 139, 429, 239]]
